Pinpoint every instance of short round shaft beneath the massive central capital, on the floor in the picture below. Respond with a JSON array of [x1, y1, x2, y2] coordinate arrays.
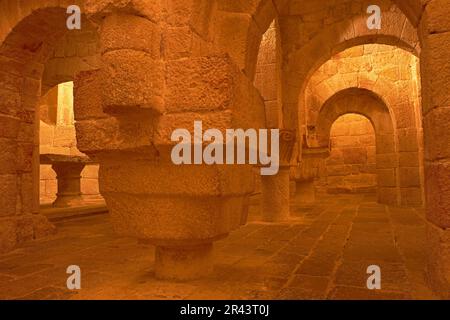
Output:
[[155, 243, 214, 281]]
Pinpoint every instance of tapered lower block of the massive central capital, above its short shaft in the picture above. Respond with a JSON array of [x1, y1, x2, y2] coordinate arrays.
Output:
[[99, 161, 253, 245]]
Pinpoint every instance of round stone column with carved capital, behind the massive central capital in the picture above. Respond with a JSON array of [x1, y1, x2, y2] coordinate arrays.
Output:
[[261, 130, 296, 222]]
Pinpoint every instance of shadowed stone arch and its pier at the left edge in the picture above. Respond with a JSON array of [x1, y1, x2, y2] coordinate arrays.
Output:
[[0, 1, 100, 249]]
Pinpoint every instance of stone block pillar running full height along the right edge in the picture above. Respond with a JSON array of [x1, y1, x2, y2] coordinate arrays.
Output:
[[419, 0, 450, 298]]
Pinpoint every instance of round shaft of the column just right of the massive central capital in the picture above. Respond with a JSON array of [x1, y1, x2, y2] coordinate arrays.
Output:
[[261, 166, 290, 222]]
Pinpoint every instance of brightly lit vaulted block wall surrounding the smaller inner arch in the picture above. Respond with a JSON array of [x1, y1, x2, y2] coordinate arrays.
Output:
[[301, 44, 424, 206]]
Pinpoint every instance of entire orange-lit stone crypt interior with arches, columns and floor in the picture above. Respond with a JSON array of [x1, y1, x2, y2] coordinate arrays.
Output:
[[0, 0, 450, 300]]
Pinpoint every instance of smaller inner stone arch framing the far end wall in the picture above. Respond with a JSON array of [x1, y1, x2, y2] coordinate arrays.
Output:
[[316, 88, 400, 205]]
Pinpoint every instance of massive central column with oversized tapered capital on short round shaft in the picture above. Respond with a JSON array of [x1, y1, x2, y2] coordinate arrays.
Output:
[[74, 7, 264, 280]]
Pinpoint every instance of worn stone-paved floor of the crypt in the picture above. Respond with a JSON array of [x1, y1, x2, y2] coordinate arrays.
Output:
[[0, 195, 436, 299]]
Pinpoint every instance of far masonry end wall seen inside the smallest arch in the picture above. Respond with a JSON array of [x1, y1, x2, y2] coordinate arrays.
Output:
[[317, 114, 377, 193]]
